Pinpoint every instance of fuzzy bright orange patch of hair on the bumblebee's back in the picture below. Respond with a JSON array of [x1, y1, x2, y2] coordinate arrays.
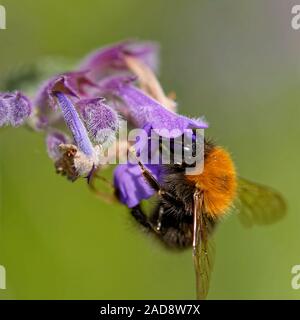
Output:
[[186, 147, 237, 217]]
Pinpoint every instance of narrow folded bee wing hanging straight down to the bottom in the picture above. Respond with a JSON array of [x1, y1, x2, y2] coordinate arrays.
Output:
[[193, 192, 215, 300]]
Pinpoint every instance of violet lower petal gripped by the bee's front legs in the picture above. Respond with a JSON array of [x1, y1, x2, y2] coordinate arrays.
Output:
[[114, 164, 161, 208]]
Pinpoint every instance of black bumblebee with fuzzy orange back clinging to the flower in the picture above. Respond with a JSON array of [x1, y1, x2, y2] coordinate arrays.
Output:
[[127, 141, 286, 299]]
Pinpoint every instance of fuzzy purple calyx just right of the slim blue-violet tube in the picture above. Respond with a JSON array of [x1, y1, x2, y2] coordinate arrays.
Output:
[[77, 98, 119, 145]]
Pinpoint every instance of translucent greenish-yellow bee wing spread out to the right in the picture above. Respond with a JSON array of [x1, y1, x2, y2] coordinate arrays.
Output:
[[234, 178, 286, 227]]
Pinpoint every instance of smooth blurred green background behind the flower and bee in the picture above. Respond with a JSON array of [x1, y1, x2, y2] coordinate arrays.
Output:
[[0, 0, 300, 299]]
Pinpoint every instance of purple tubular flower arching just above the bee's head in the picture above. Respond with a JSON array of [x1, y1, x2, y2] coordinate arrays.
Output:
[[99, 76, 208, 137]]
